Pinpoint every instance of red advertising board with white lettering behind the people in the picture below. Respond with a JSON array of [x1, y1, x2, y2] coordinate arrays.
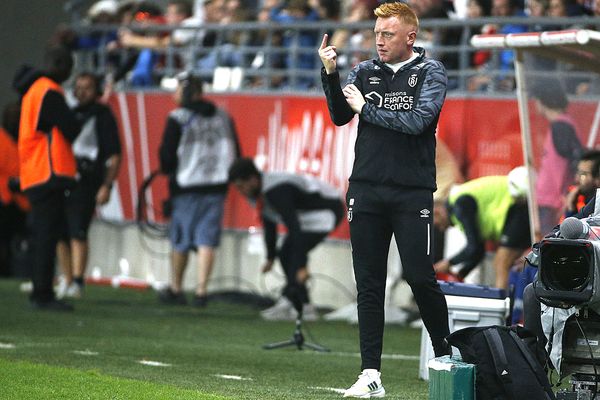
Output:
[[109, 92, 595, 239]]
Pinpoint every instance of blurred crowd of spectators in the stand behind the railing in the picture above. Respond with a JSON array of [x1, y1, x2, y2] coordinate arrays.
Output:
[[48, 0, 600, 93]]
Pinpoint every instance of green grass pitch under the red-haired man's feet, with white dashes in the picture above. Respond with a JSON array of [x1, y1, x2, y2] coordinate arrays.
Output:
[[0, 280, 428, 400]]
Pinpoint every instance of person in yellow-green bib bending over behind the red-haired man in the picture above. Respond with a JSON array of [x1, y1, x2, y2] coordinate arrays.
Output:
[[434, 167, 531, 289]]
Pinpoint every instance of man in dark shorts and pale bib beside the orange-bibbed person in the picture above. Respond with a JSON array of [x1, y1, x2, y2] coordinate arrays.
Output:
[[56, 72, 121, 299]]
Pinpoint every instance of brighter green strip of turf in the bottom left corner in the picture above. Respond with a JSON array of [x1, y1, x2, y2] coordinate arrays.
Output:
[[0, 358, 228, 400]]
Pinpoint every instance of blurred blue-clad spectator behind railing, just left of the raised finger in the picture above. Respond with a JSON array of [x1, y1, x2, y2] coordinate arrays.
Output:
[[270, 0, 319, 89]]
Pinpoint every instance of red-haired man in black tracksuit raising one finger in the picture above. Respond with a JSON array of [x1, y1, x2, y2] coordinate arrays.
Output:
[[319, 2, 449, 397]]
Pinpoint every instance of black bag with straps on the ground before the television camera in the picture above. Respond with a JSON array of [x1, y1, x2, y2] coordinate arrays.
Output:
[[447, 326, 555, 400]]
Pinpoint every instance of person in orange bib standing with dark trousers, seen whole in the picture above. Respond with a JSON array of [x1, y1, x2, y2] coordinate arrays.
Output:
[[13, 48, 81, 311]]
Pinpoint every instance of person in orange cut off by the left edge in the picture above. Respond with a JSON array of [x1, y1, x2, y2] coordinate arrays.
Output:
[[0, 103, 29, 276]]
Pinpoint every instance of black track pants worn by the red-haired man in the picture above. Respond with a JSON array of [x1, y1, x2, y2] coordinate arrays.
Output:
[[347, 182, 449, 370]]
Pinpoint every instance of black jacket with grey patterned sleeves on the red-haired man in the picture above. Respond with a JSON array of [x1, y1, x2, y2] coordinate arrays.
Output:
[[321, 48, 447, 191]]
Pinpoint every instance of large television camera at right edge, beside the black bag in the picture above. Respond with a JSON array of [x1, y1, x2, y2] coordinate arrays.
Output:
[[530, 217, 600, 400]]
